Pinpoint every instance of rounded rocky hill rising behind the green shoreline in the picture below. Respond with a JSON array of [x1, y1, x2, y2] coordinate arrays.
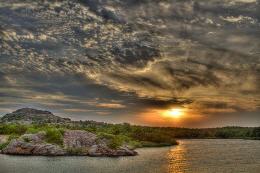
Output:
[[0, 108, 71, 123]]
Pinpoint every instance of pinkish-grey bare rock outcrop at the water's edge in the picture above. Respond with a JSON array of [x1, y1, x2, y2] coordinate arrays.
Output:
[[2, 130, 137, 157]]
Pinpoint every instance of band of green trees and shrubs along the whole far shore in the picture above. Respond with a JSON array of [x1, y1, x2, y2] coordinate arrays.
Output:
[[0, 121, 260, 149]]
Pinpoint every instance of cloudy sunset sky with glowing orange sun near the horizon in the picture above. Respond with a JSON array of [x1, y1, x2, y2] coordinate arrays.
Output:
[[0, 0, 260, 127]]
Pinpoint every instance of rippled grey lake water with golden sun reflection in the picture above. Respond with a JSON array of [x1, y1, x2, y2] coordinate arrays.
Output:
[[0, 139, 260, 173]]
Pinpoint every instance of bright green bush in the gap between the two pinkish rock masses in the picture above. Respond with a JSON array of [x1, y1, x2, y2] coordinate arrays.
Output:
[[46, 128, 63, 146]]
